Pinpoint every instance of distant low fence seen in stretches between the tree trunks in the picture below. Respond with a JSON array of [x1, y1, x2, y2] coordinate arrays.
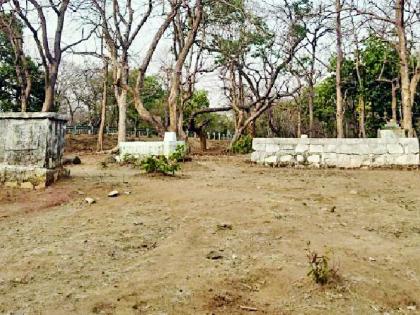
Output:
[[66, 125, 233, 140]]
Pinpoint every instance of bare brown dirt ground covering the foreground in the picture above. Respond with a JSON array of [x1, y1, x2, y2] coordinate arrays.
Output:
[[0, 137, 420, 314]]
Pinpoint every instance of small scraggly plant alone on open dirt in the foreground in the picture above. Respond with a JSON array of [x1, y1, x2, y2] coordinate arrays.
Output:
[[306, 242, 338, 285]]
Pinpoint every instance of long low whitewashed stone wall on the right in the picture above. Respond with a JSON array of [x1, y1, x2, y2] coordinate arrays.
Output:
[[251, 137, 419, 168]]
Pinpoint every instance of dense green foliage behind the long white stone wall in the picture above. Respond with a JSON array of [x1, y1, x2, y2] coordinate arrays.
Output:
[[314, 35, 420, 137]]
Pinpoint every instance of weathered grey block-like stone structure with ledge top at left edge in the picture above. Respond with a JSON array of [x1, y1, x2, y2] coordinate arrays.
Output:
[[0, 113, 66, 187]]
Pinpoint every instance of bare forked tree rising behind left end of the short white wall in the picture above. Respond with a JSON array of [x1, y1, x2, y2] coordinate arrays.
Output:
[[91, 0, 181, 142]]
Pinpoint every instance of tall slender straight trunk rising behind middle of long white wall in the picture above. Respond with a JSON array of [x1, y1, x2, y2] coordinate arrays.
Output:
[[336, 0, 344, 138]]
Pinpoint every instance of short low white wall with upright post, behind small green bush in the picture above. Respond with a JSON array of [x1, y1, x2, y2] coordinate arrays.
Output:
[[119, 132, 185, 160]]
